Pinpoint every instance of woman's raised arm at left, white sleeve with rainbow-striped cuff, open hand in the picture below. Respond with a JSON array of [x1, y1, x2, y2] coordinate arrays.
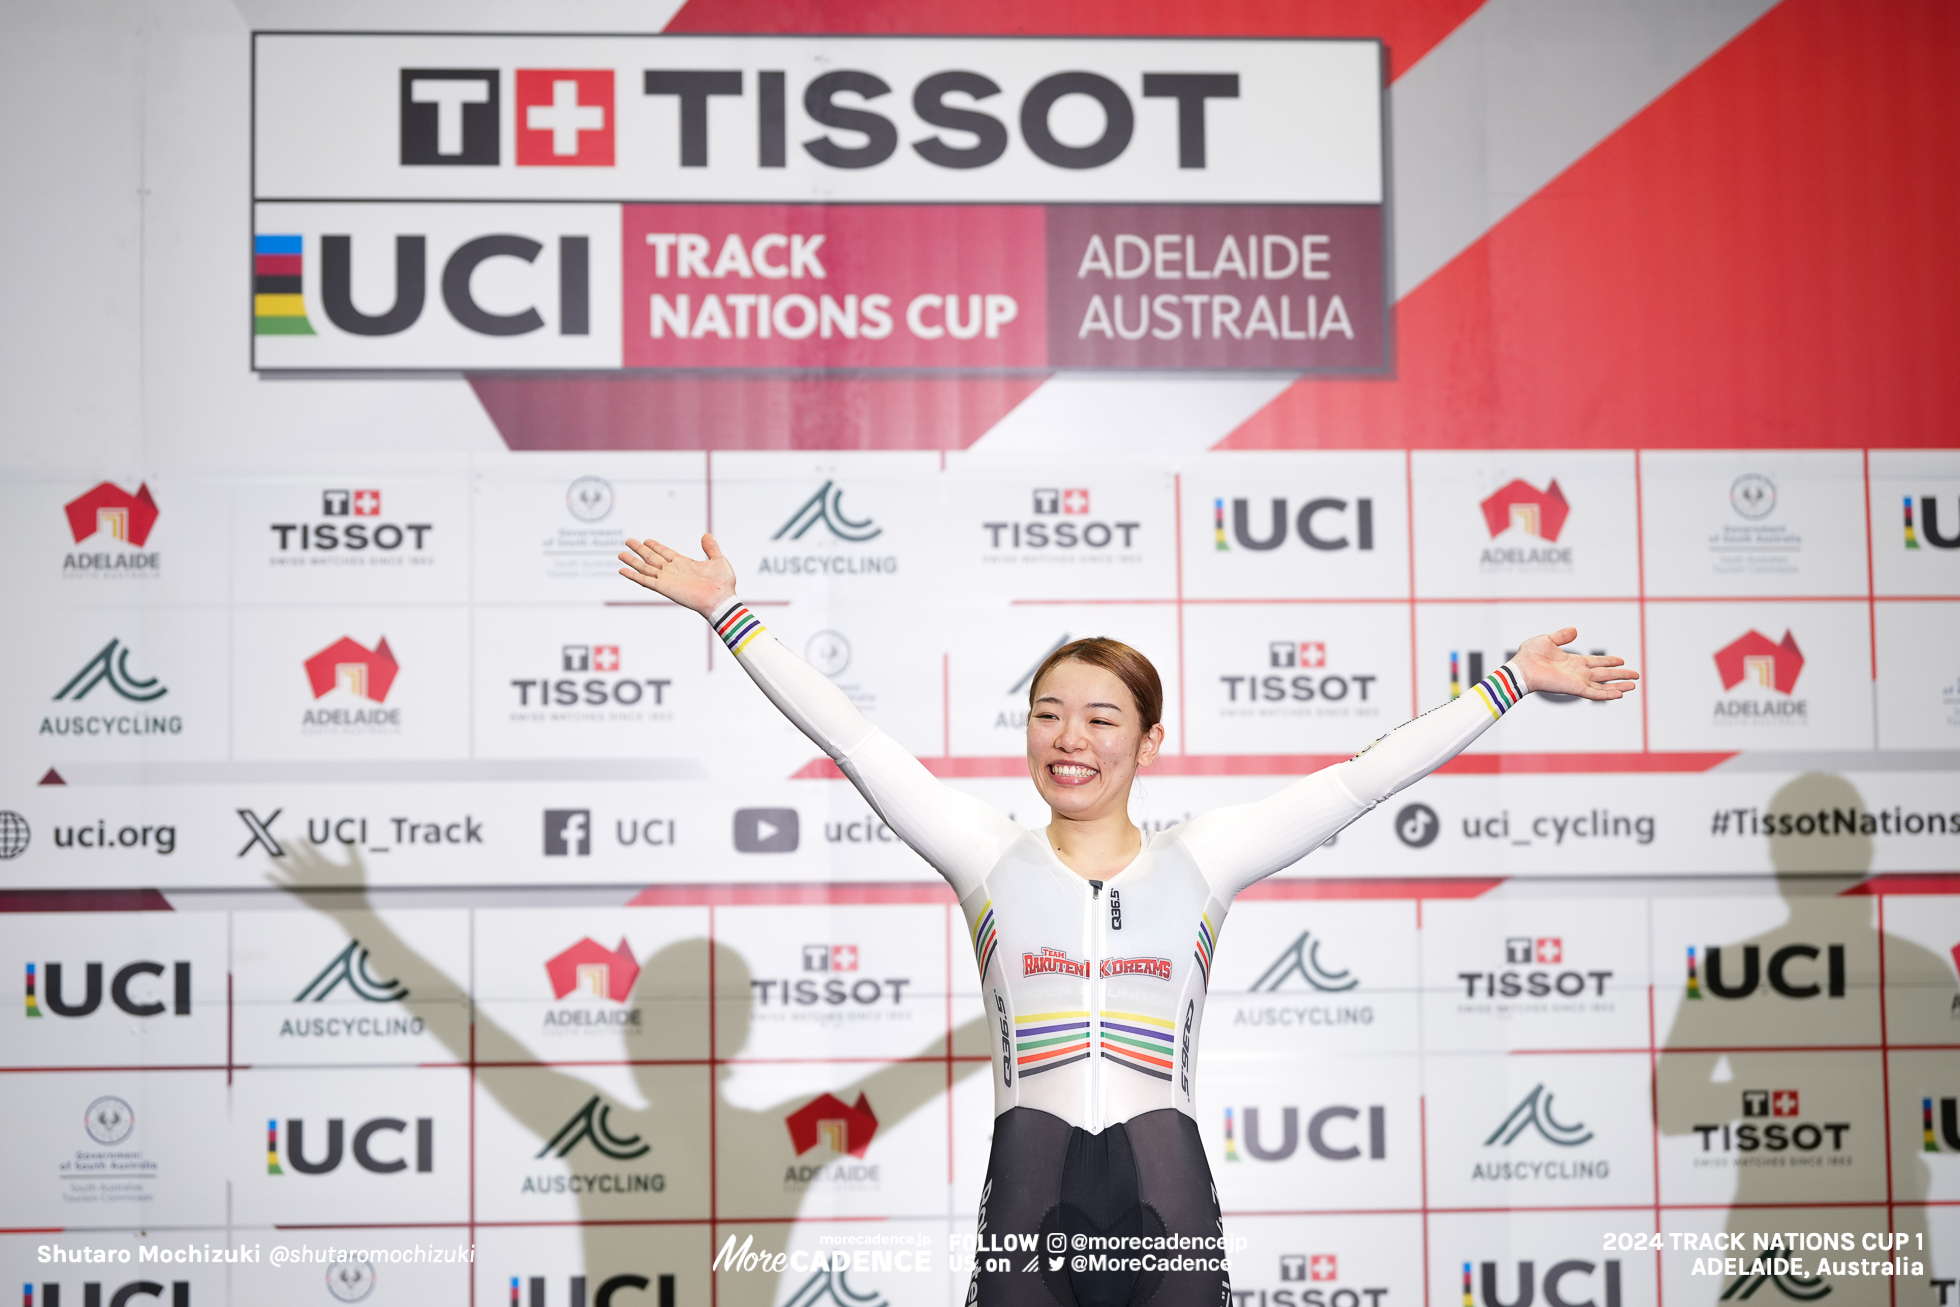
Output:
[[619, 535, 1021, 899]]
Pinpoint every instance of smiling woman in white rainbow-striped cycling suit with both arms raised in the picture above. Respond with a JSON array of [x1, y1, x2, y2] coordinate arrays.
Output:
[[619, 535, 1639, 1307]]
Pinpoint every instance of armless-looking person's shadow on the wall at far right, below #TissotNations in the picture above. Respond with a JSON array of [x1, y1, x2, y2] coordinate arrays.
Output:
[[1658, 772, 1944, 1305]]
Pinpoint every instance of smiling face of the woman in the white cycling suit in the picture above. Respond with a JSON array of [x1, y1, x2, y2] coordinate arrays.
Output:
[[1027, 660, 1164, 819]]
